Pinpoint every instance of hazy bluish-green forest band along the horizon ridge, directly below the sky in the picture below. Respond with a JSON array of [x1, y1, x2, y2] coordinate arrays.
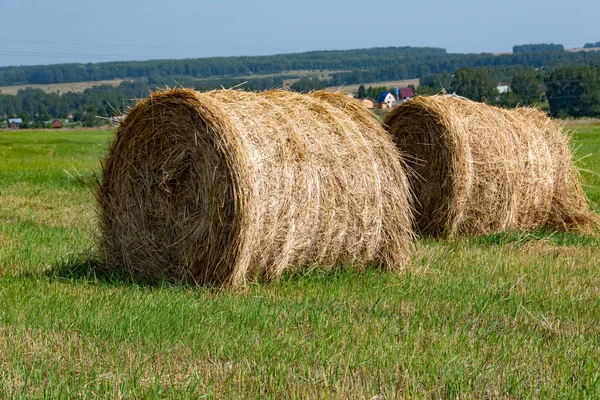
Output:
[[0, 44, 595, 86]]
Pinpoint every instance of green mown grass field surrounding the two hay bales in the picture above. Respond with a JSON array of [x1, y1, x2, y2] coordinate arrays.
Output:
[[0, 123, 600, 399]]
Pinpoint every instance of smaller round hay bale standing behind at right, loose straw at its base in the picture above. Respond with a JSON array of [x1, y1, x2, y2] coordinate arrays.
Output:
[[384, 96, 598, 236]]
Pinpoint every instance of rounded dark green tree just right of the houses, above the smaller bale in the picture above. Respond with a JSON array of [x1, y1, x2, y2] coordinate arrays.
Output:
[[450, 68, 498, 102]]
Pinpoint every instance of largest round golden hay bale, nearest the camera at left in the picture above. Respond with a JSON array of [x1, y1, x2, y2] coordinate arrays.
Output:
[[97, 89, 412, 286]]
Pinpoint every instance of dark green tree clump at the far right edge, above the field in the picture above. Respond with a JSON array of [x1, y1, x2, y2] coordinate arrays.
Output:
[[546, 67, 600, 118]]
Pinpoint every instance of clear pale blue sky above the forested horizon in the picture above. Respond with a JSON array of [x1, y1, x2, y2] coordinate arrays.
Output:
[[0, 0, 600, 66]]
